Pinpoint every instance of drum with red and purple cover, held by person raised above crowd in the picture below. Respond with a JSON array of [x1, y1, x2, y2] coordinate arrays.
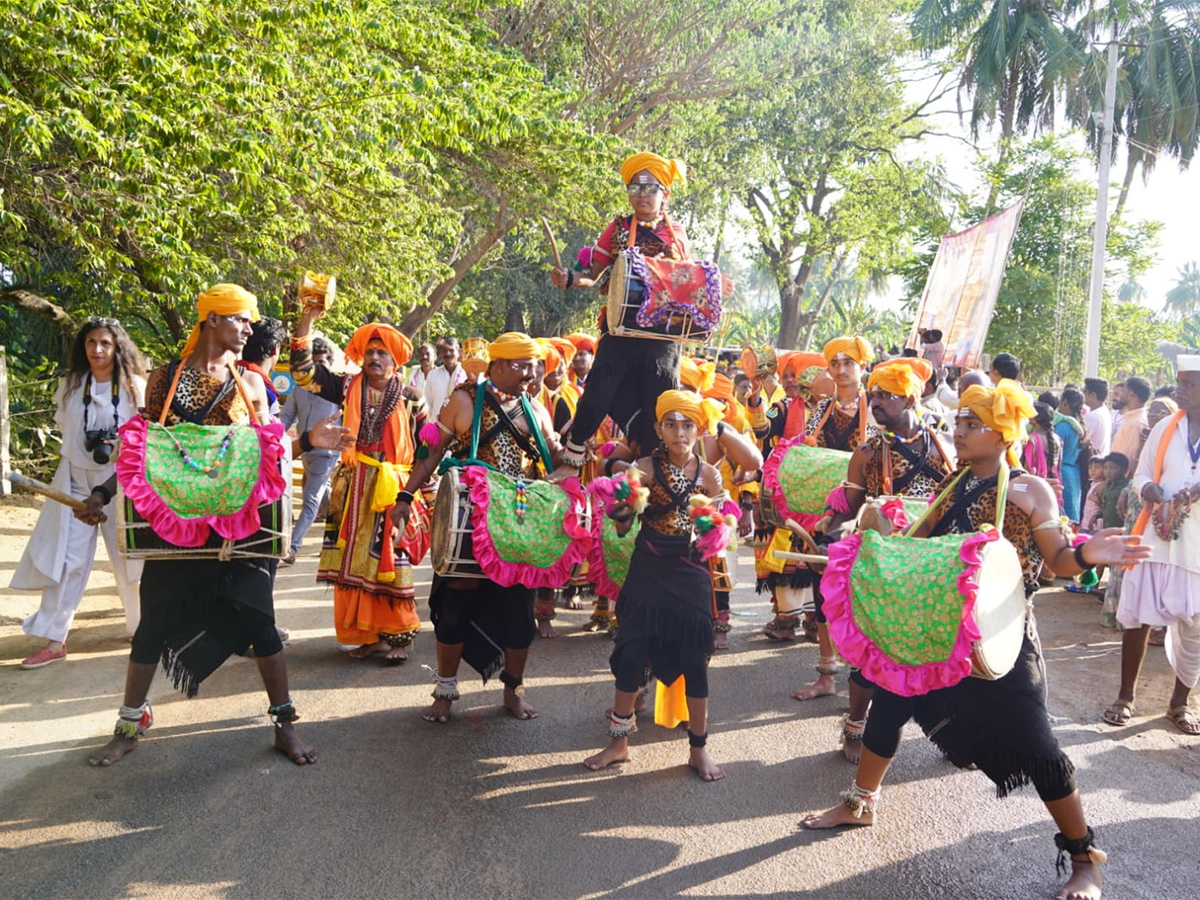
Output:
[[606, 247, 732, 343]]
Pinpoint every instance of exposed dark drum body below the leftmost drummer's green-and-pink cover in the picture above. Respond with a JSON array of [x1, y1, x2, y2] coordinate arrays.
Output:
[[116, 487, 292, 559]]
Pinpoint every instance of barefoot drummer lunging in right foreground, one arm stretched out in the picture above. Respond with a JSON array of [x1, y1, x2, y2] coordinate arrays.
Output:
[[803, 378, 1150, 899]]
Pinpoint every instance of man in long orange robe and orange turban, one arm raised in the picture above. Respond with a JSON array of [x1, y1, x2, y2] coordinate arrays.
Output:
[[292, 305, 431, 665]]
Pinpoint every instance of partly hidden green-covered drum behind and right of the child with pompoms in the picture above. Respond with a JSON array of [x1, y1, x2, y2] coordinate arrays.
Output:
[[760, 436, 851, 530]]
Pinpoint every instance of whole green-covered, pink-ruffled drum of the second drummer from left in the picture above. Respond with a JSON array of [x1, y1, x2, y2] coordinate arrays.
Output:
[[431, 466, 592, 588]]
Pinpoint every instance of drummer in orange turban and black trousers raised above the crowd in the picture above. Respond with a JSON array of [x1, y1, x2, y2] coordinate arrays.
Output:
[[551, 152, 691, 476]]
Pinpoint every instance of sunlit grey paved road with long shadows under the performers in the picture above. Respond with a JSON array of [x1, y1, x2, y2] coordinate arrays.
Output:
[[0, 535, 1200, 899]]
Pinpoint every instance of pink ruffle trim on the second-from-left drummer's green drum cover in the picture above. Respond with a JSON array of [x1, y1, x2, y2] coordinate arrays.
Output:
[[462, 466, 592, 588]]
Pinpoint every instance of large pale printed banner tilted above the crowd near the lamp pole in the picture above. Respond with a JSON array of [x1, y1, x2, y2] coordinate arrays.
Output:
[[906, 198, 1025, 368]]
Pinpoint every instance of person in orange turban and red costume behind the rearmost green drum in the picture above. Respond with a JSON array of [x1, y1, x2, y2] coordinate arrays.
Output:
[[746, 352, 828, 641]]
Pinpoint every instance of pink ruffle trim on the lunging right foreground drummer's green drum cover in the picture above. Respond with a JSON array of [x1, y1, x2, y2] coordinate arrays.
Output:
[[821, 529, 1000, 697]]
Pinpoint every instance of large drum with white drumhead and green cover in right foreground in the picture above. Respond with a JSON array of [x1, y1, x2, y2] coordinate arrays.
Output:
[[821, 528, 1026, 697]]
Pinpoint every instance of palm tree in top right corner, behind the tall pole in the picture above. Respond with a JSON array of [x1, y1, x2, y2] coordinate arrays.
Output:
[[1067, 0, 1200, 217]]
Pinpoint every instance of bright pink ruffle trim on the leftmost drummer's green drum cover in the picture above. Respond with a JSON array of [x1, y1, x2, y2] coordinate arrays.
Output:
[[116, 415, 288, 547]]
